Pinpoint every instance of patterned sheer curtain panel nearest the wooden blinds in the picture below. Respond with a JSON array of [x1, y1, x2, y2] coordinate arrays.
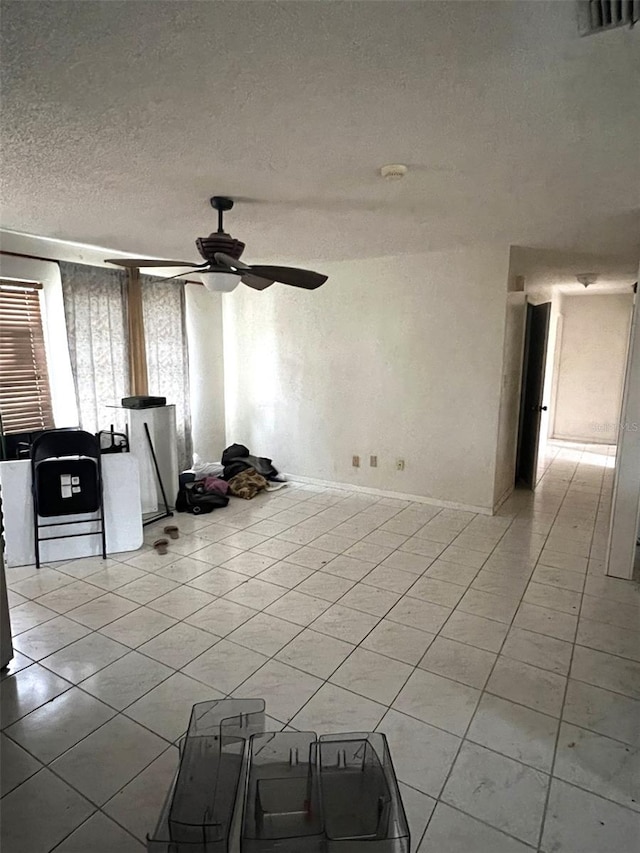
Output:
[[60, 262, 129, 433]]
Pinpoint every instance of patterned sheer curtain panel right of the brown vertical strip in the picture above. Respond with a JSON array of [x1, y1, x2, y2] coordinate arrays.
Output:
[[140, 275, 192, 470]]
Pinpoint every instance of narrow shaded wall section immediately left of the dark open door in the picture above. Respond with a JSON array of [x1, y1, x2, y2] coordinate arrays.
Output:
[[493, 292, 527, 506]]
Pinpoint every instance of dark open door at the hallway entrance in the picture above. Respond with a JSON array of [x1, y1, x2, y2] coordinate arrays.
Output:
[[516, 302, 551, 489]]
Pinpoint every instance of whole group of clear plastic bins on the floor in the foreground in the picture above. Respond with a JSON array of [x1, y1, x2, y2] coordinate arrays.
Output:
[[147, 699, 410, 853]]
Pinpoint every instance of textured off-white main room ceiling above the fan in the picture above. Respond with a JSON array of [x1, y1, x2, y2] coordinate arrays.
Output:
[[2, 0, 640, 261]]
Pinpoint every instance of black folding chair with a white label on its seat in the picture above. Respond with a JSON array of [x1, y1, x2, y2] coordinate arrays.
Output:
[[31, 429, 107, 569]]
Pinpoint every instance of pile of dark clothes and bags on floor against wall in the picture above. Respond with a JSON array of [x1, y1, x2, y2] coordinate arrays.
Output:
[[176, 444, 285, 514]]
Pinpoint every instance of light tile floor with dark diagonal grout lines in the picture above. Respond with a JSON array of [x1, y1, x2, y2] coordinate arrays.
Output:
[[1, 445, 640, 853]]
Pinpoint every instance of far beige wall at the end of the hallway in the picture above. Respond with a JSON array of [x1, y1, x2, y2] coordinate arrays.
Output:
[[552, 292, 633, 443]]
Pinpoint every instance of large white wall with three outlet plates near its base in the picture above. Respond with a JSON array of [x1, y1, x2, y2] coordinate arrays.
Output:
[[223, 247, 509, 511]]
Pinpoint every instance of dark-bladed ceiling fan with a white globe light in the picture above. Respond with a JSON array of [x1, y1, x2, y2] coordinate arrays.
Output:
[[105, 195, 328, 293]]
